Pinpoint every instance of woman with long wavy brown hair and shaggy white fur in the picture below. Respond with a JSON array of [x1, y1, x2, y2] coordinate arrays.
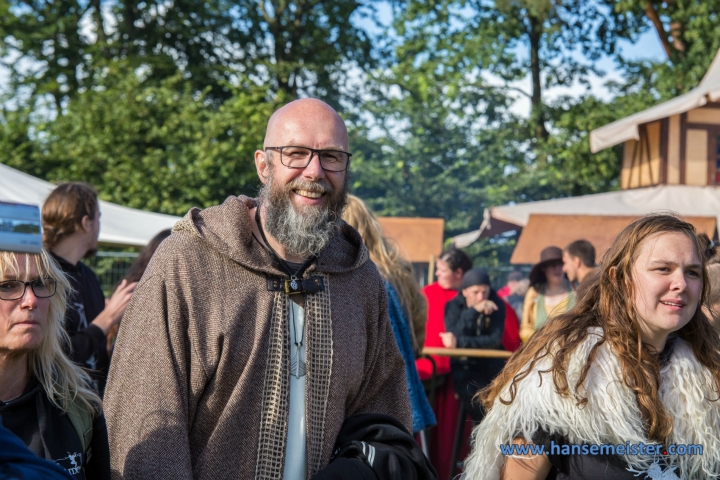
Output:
[[465, 215, 720, 480]]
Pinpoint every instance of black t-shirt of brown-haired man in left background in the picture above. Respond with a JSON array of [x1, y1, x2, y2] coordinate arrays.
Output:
[[52, 254, 110, 396]]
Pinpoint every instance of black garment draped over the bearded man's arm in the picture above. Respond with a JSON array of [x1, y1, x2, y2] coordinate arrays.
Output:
[[313, 413, 438, 480]]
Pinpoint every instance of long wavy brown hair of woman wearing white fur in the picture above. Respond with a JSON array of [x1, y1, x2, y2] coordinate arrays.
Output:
[[478, 215, 720, 442]]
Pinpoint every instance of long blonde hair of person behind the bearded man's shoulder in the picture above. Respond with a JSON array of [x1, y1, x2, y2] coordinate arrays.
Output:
[[343, 195, 427, 352]]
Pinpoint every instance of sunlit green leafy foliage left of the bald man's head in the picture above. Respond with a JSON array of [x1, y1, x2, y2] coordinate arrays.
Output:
[[6, 63, 280, 215]]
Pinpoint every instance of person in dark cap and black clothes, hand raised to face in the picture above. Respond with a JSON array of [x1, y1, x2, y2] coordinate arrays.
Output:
[[440, 268, 506, 422]]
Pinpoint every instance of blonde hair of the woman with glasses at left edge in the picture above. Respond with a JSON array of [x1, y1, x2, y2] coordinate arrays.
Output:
[[0, 250, 102, 413]]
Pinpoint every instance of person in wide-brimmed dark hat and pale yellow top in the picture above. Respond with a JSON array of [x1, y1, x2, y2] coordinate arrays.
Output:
[[520, 246, 575, 342]]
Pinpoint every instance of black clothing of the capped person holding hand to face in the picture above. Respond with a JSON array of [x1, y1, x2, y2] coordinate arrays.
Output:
[[445, 290, 505, 422]]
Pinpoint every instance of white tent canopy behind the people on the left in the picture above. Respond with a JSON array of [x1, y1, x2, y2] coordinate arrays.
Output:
[[0, 163, 180, 246]]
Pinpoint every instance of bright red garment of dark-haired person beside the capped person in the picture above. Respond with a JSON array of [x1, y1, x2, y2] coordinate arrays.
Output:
[[415, 282, 457, 378]]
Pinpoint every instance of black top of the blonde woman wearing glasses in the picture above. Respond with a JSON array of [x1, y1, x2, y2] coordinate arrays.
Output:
[[0, 377, 110, 480]]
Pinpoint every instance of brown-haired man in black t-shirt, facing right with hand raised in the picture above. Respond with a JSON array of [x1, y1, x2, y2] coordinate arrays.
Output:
[[42, 182, 136, 395]]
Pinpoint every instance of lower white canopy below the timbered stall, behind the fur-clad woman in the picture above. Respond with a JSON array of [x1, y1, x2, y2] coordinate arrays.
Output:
[[453, 185, 720, 248]]
